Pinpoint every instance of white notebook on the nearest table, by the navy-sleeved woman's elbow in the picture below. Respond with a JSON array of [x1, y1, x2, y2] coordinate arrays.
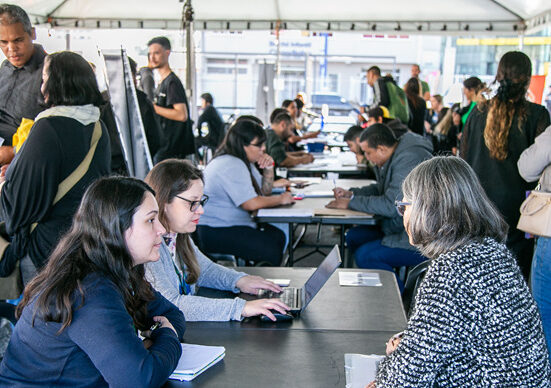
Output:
[[169, 344, 226, 381]]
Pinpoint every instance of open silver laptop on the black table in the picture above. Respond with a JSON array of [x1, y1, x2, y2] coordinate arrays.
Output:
[[259, 245, 342, 314]]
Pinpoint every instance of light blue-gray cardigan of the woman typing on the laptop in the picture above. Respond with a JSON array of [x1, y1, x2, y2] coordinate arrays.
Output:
[[145, 241, 247, 321]]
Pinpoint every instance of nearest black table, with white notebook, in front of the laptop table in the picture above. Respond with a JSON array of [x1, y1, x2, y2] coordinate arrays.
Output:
[[166, 328, 395, 388]]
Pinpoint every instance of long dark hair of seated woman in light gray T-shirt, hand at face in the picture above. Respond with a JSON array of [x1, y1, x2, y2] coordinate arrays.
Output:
[[214, 120, 266, 195]]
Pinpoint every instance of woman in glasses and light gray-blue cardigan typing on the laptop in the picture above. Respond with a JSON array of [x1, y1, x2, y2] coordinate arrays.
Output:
[[145, 159, 288, 321]]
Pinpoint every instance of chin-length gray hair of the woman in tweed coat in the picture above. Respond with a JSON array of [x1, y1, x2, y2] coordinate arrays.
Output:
[[402, 156, 508, 258]]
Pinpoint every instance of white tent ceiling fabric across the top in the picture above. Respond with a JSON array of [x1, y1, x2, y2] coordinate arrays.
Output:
[[8, 0, 551, 34]]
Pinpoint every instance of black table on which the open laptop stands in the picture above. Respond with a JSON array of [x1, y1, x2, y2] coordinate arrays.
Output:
[[187, 267, 406, 332]]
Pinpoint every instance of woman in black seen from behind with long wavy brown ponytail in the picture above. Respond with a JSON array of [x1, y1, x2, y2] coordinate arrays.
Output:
[[460, 51, 550, 277]]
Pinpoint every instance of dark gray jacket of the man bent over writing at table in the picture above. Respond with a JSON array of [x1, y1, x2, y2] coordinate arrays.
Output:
[[348, 132, 432, 250]]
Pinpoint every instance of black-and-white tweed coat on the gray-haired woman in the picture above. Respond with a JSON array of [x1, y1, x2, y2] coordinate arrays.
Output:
[[376, 238, 551, 388]]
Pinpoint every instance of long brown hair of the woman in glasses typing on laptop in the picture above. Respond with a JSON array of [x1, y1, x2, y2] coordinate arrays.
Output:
[[145, 159, 203, 284]]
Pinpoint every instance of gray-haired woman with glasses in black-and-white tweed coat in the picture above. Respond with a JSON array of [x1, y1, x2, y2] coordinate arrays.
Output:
[[369, 157, 551, 387]]
